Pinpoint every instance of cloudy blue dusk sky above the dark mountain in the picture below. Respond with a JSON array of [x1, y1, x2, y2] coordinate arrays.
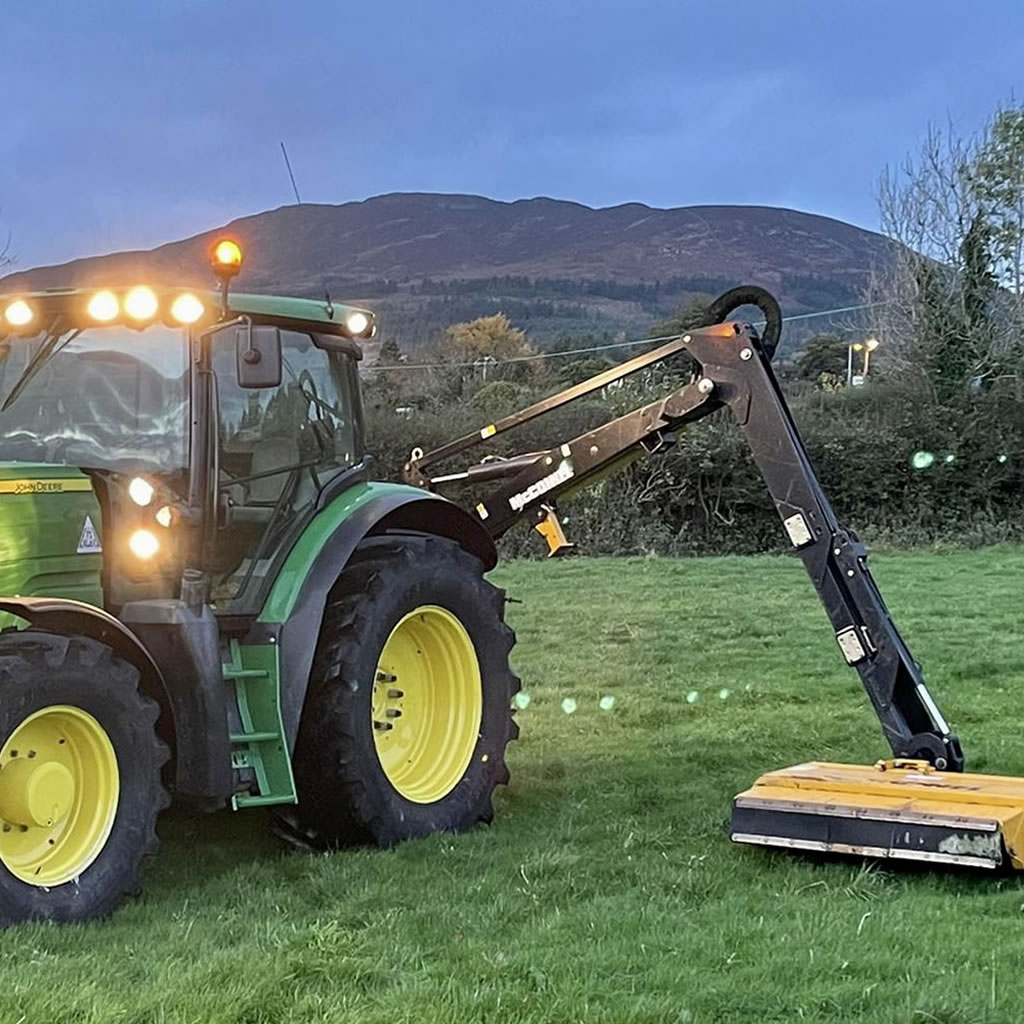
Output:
[[0, 0, 1024, 268]]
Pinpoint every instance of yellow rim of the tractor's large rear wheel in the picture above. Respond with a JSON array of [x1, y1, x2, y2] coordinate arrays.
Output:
[[372, 604, 483, 804]]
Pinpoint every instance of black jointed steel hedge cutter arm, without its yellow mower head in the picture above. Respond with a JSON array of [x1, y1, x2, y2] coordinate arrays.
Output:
[[406, 290, 964, 771]]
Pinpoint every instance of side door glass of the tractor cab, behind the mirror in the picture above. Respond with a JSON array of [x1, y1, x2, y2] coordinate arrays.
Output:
[[211, 331, 362, 611]]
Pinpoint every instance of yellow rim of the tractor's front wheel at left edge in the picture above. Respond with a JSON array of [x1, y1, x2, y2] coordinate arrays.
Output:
[[0, 705, 120, 886]]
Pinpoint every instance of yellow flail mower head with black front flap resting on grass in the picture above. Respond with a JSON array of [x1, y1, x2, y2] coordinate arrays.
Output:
[[730, 760, 1024, 869]]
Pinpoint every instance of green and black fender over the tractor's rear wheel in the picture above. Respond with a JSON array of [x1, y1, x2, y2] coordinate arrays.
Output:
[[257, 482, 498, 751]]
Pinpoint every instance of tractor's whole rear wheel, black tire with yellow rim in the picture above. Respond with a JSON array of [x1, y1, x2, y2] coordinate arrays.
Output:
[[295, 535, 519, 846]]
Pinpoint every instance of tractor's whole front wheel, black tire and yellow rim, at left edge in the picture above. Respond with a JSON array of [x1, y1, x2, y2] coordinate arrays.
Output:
[[0, 631, 167, 927]]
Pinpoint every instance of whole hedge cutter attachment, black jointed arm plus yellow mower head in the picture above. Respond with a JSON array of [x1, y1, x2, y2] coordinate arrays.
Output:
[[406, 288, 1024, 868]]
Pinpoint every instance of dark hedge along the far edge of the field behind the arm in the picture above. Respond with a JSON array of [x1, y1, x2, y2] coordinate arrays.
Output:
[[369, 381, 1024, 557]]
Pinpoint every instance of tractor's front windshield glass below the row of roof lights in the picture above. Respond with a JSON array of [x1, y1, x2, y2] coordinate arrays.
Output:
[[0, 325, 188, 472]]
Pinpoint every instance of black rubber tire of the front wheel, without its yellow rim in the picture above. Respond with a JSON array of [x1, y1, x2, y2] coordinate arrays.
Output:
[[0, 631, 168, 927]]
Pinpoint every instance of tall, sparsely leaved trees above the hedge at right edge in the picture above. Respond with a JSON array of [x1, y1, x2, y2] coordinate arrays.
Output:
[[869, 108, 1024, 403]]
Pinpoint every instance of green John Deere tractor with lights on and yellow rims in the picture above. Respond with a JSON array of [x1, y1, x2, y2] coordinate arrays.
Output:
[[0, 241, 518, 925]]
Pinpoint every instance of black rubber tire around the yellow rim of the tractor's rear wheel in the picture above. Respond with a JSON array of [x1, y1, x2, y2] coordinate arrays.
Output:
[[295, 534, 519, 847]]
